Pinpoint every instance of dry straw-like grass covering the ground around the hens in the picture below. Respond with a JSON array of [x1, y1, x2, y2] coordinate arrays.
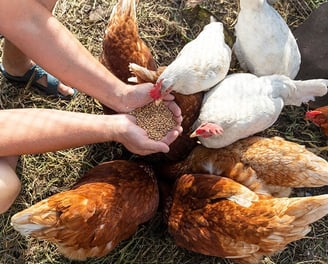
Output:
[[0, 0, 328, 264]]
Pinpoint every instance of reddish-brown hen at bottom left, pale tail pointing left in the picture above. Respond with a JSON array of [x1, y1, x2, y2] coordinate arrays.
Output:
[[11, 160, 159, 260]]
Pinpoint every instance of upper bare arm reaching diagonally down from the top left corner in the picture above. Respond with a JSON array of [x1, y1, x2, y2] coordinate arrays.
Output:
[[0, 0, 159, 112]]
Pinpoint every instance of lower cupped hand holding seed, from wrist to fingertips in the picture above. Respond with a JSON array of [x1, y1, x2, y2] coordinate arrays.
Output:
[[111, 114, 182, 155]]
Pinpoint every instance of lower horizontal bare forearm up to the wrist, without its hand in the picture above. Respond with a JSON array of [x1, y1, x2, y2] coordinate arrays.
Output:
[[0, 109, 115, 156]]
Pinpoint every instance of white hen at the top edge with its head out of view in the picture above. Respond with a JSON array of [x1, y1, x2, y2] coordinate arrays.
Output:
[[233, 0, 301, 79]]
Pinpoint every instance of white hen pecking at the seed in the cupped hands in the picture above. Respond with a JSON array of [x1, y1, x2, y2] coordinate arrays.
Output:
[[151, 18, 231, 100]]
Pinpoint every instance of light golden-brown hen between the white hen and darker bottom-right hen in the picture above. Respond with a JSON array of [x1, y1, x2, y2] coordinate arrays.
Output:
[[156, 136, 328, 197]]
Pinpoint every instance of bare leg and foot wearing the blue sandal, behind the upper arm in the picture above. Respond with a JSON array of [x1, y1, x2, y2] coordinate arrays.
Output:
[[2, 0, 74, 95]]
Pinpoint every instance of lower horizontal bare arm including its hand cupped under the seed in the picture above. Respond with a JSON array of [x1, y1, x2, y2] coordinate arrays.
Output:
[[0, 108, 180, 157]]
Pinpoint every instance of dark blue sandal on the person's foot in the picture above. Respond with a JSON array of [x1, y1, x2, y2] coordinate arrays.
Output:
[[0, 64, 77, 100]]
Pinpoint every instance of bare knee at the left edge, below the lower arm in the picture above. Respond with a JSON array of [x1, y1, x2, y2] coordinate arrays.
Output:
[[0, 156, 21, 214]]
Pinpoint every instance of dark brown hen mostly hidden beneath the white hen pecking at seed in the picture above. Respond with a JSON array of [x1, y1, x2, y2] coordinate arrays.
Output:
[[130, 63, 204, 161]]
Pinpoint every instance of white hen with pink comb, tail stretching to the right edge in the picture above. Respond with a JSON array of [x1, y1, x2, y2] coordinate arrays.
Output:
[[191, 73, 328, 148]]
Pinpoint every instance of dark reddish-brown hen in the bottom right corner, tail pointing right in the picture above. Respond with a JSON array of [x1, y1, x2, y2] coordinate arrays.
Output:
[[168, 174, 328, 264]]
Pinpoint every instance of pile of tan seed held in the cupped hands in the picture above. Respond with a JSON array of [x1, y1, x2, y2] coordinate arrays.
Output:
[[130, 102, 176, 141]]
